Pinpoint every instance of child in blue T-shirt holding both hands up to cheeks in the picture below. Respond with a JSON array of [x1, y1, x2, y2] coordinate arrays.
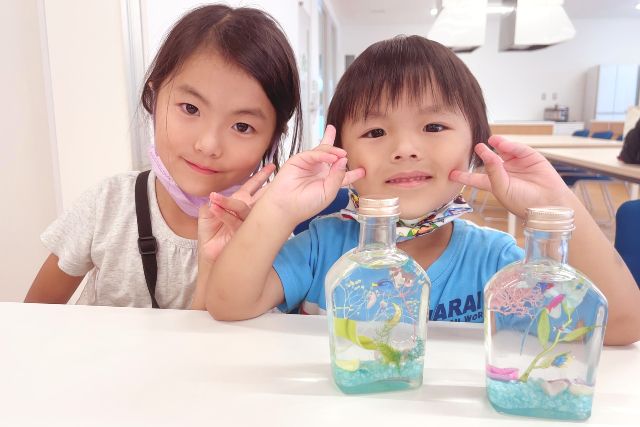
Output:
[[201, 36, 640, 344]]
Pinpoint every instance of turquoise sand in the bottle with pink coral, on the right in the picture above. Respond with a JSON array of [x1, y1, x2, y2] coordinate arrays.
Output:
[[487, 378, 593, 420]]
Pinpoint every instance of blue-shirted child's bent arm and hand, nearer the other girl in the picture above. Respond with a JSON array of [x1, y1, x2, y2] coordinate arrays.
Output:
[[206, 126, 364, 320]]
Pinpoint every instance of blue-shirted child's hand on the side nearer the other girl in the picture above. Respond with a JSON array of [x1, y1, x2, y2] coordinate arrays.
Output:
[[264, 125, 365, 225]]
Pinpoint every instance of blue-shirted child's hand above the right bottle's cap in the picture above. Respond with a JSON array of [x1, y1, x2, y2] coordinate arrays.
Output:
[[449, 136, 575, 218]]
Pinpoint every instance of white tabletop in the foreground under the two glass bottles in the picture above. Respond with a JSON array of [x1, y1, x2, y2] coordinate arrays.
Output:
[[0, 303, 640, 427]]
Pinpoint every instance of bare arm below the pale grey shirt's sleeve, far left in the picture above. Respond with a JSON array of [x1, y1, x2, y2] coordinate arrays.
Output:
[[24, 254, 84, 304]]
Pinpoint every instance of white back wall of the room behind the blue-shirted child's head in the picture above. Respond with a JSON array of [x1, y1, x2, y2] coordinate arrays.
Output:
[[339, 16, 640, 121]]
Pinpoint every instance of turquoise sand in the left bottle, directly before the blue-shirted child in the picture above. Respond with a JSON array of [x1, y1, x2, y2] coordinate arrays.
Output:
[[331, 359, 424, 394]]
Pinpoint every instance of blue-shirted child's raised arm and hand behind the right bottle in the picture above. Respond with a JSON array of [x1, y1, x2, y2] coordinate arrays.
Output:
[[450, 136, 640, 345]]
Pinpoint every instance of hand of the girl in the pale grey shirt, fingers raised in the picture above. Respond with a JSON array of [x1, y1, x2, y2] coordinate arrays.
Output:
[[198, 164, 275, 262]]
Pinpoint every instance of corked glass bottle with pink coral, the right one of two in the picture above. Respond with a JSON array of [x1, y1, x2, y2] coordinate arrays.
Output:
[[484, 207, 607, 420]]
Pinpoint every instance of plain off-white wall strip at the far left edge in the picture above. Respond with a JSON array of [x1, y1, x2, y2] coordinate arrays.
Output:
[[0, 0, 56, 301]]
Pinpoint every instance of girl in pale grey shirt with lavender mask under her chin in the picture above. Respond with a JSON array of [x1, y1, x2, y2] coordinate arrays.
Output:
[[25, 5, 301, 308]]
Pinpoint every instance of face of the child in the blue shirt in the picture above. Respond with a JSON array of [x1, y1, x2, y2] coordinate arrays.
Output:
[[341, 96, 472, 219]]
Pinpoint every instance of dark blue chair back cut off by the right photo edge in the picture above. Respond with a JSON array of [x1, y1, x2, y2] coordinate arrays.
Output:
[[614, 200, 640, 287]]
